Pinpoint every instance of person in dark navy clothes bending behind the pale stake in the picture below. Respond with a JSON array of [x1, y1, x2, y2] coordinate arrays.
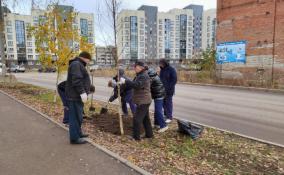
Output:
[[109, 69, 136, 116]]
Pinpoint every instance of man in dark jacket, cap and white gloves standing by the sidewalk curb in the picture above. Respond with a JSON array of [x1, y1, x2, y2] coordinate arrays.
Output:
[[66, 52, 92, 144]]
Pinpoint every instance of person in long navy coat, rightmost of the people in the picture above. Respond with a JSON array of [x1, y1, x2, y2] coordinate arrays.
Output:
[[159, 59, 177, 123]]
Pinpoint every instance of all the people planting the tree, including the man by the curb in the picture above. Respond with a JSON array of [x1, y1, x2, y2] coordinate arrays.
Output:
[[58, 51, 177, 144]]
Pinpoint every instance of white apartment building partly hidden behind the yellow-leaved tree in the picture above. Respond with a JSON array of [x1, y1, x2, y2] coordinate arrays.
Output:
[[4, 6, 94, 66]]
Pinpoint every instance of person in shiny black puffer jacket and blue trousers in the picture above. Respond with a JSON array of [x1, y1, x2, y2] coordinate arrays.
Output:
[[148, 69, 168, 133]]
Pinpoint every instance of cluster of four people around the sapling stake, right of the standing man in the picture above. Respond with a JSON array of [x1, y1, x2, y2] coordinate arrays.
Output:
[[109, 59, 177, 140]]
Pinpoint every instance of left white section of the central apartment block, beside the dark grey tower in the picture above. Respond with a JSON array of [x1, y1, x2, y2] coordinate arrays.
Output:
[[117, 10, 145, 63]]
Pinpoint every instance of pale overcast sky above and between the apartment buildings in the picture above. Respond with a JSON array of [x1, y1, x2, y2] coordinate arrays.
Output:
[[8, 0, 217, 45]]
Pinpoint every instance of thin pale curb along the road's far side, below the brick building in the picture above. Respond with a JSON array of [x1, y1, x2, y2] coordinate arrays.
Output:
[[178, 82, 284, 94]]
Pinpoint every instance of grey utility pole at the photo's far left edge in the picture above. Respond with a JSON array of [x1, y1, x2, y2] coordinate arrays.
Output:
[[0, 0, 6, 76]]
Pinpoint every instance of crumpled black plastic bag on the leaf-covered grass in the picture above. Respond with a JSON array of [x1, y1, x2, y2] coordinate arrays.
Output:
[[177, 120, 204, 139]]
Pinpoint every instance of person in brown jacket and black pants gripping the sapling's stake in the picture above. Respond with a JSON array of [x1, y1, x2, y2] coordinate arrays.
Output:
[[119, 61, 153, 141]]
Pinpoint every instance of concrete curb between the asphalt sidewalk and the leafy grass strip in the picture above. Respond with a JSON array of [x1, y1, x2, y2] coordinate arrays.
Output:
[[0, 90, 151, 175]]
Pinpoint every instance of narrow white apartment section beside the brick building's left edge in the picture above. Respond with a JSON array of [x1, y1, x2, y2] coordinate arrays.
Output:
[[202, 9, 217, 51]]
